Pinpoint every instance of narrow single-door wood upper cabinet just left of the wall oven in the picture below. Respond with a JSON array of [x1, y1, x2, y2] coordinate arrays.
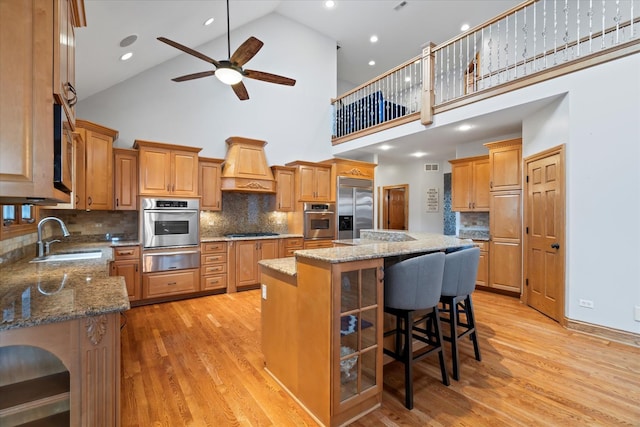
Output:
[[113, 148, 138, 211]]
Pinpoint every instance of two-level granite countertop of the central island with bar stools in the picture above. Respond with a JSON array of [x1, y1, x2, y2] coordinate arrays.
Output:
[[259, 230, 473, 276]]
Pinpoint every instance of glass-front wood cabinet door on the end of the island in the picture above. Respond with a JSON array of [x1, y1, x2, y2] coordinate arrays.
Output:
[[332, 259, 383, 413]]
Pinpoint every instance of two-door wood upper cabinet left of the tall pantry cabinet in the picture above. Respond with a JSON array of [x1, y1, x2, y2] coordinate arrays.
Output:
[[449, 156, 489, 212]]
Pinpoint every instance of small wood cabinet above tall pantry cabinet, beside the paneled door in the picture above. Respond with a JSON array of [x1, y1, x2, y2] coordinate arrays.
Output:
[[484, 139, 522, 191]]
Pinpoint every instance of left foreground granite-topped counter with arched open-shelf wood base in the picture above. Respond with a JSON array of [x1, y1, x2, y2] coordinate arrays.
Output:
[[0, 242, 129, 426]]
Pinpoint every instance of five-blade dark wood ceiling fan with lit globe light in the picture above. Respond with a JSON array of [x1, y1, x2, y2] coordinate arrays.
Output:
[[158, 0, 296, 101]]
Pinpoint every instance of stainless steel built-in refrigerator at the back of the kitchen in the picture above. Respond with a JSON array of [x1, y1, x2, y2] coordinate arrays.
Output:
[[337, 177, 373, 239]]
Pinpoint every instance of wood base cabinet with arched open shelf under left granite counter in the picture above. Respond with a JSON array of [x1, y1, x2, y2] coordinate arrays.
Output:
[[0, 313, 120, 426]]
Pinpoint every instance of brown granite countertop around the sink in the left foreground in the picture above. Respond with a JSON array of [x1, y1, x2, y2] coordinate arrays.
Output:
[[0, 241, 131, 331]]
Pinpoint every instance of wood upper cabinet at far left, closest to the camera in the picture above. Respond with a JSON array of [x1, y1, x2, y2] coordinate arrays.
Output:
[[0, 1, 82, 204]]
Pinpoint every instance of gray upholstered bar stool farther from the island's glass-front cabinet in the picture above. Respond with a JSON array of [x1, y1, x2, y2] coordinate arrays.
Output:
[[440, 247, 481, 380]]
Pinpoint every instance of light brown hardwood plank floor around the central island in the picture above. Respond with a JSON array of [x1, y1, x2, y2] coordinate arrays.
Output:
[[122, 290, 640, 427]]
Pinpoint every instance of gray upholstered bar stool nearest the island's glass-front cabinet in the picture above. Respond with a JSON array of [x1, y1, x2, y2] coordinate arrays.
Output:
[[384, 252, 449, 409]]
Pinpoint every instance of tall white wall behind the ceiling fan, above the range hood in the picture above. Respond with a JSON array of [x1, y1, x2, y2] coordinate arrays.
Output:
[[77, 14, 337, 164]]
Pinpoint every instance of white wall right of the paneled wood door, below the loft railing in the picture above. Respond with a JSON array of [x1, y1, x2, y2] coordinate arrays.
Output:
[[523, 54, 640, 333]]
